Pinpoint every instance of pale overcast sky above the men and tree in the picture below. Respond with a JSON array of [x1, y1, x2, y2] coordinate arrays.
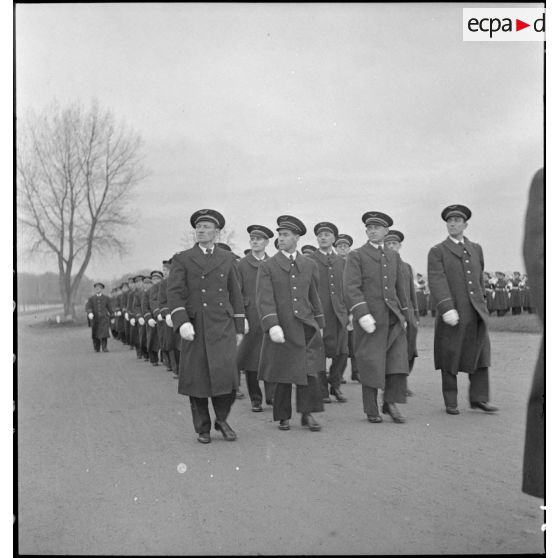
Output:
[[16, 3, 543, 279]]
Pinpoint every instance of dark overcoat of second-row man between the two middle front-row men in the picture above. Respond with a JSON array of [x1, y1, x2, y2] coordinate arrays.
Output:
[[307, 250, 349, 358]]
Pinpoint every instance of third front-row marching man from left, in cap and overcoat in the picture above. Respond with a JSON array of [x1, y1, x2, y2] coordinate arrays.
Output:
[[343, 211, 409, 423]]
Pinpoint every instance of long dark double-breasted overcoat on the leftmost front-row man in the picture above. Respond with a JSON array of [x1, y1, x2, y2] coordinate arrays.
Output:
[[167, 245, 244, 397]]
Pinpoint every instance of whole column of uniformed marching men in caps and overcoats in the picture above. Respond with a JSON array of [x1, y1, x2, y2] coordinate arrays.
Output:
[[86, 205, 504, 443]]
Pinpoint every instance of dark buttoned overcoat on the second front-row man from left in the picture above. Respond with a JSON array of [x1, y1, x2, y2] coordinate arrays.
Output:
[[256, 252, 326, 386]]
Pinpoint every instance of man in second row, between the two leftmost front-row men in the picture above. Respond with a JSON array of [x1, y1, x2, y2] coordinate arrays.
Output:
[[237, 225, 274, 413]]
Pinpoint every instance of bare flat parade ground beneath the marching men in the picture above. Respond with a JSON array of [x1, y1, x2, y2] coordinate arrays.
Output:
[[16, 316, 543, 555]]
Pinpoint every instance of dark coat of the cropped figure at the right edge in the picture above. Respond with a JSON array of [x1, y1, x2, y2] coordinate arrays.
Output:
[[522, 169, 545, 498]]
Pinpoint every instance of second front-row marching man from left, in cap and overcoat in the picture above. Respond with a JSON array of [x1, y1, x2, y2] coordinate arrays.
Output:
[[256, 215, 325, 431]]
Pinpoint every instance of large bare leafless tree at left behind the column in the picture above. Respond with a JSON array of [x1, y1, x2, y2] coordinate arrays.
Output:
[[17, 101, 147, 318]]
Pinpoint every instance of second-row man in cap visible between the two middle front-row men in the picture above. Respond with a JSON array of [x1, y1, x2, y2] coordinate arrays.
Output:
[[308, 221, 349, 403]]
